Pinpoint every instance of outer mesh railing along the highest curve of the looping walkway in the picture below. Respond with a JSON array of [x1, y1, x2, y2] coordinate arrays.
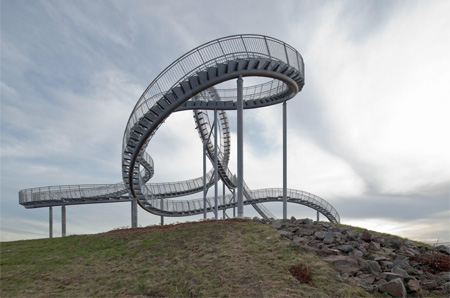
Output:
[[123, 35, 304, 155]]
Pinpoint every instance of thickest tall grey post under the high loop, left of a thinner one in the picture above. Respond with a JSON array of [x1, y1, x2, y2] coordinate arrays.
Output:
[[237, 75, 244, 217]]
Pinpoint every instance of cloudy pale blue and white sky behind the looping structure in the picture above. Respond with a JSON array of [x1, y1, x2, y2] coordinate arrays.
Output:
[[0, 0, 450, 243]]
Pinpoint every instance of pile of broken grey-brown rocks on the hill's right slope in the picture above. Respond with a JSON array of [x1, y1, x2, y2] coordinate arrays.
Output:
[[253, 217, 450, 297]]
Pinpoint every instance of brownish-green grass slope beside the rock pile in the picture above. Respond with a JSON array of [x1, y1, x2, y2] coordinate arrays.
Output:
[[0, 219, 368, 297]]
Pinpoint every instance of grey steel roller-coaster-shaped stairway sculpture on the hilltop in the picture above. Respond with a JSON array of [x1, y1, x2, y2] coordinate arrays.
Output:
[[19, 35, 340, 235]]
